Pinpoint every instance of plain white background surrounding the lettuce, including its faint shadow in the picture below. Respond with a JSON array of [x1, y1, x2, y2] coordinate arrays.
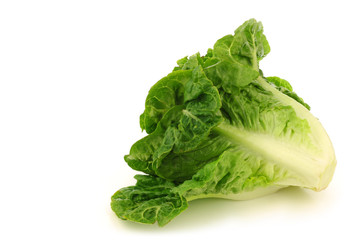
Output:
[[0, 0, 360, 240]]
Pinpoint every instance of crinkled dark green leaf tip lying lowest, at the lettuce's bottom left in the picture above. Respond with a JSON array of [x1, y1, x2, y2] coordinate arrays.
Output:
[[111, 175, 188, 226]]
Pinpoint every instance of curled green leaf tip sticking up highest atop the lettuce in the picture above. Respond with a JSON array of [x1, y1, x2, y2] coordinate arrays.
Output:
[[206, 19, 270, 93]]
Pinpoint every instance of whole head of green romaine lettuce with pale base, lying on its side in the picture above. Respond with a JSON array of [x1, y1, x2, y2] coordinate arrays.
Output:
[[111, 19, 336, 226]]
